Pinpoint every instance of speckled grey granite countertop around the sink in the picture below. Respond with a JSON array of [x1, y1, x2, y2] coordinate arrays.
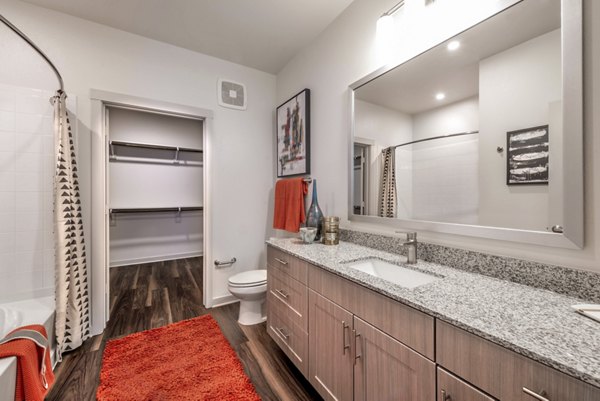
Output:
[[267, 238, 600, 387]]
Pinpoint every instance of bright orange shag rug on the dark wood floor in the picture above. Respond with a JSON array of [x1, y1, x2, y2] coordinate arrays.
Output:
[[96, 315, 260, 401]]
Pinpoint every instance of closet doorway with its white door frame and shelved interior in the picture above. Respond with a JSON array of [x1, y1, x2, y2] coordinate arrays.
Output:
[[92, 91, 211, 333]]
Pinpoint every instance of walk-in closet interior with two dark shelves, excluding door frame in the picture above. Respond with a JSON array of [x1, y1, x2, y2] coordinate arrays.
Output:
[[105, 106, 205, 318]]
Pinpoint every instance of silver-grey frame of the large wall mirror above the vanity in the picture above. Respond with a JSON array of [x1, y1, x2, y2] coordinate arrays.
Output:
[[348, 0, 584, 249]]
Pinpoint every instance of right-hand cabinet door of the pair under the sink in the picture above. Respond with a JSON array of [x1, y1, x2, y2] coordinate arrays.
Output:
[[353, 316, 436, 401]]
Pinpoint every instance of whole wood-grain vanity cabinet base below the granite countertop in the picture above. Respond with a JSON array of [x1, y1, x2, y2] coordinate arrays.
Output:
[[267, 246, 600, 401]]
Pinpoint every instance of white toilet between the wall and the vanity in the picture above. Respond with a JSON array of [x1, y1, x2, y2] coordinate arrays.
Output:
[[228, 270, 267, 326]]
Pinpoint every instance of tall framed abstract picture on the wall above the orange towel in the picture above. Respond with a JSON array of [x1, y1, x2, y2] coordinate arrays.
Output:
[[276, 89, 310, 178]]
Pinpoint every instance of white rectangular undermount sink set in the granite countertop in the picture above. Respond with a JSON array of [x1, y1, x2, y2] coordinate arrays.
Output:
[[347, 258, 440, 288]]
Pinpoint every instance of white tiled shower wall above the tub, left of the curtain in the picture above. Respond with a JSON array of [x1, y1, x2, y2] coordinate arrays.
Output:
[[0, 84, 76, 302]]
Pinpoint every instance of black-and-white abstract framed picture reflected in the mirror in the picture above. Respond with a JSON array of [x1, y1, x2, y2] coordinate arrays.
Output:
[[506, 125, 550, 185]]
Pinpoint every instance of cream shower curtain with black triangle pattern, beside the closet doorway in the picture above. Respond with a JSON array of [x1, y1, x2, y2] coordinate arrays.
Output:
[[53, 90, 90, 361]]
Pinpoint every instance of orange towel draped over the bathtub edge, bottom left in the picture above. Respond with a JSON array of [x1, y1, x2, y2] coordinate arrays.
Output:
[[0, 324, 54, 401]]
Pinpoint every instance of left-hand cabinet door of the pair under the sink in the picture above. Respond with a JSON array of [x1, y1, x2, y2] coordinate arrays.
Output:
[[308, 291, 353, 401]]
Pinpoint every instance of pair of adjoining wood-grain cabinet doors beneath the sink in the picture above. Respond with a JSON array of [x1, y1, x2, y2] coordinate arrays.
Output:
[[308, 290, 435, 401]]
